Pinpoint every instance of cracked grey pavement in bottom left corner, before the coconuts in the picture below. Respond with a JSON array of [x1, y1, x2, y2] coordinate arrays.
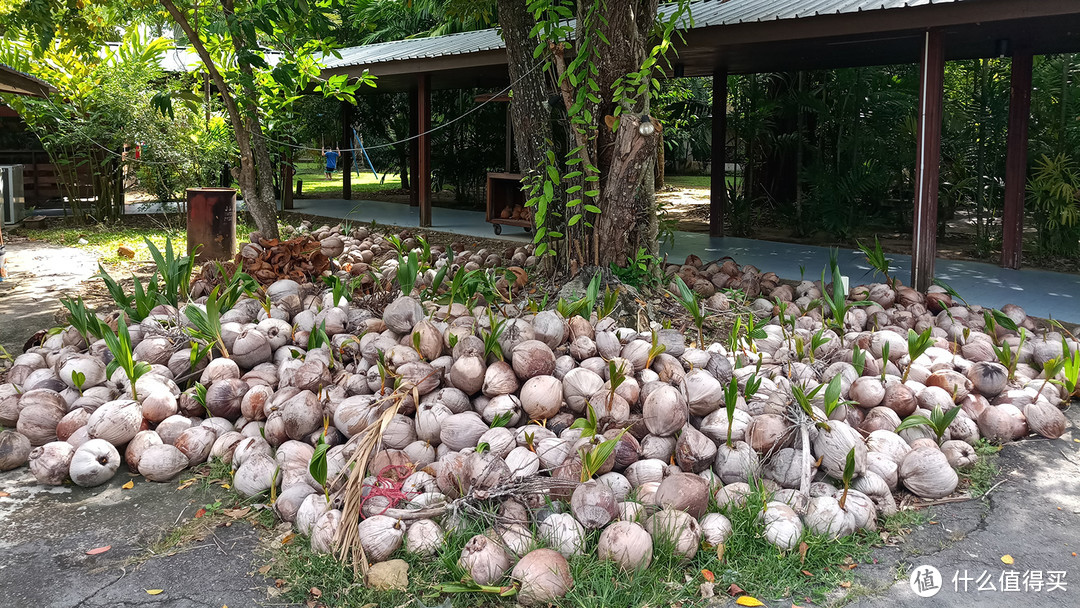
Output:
[[0, 467, 285, 608]]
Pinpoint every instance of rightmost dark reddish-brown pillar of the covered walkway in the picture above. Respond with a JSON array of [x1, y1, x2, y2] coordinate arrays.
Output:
[[1001, 49, 1031, 270]]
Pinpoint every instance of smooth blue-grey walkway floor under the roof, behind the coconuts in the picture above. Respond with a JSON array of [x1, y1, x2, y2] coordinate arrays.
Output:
[[294, 200, 1080, 323]]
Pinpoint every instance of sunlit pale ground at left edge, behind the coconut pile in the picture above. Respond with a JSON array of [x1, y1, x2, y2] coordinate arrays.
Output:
[[0, 239, 97, 355]]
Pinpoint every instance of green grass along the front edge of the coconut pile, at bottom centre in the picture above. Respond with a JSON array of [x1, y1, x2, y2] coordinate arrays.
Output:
[[268, 485, 881, 608]]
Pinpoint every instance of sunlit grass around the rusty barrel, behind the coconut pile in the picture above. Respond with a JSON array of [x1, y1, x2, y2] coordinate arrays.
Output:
[[16, 214, 261, 269]]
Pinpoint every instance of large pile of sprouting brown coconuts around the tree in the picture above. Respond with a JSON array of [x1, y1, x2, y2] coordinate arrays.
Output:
[[0, 228, 1078, 604]]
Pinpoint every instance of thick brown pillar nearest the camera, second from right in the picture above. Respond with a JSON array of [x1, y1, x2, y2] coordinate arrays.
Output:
[[912, 29, 945, 292]]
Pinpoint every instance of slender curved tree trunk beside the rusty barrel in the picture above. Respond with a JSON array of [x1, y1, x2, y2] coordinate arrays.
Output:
[[161, 0, 279, 239]]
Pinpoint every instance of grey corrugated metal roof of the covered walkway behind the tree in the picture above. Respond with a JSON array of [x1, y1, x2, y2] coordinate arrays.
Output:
[[324, 0, 963, 69]]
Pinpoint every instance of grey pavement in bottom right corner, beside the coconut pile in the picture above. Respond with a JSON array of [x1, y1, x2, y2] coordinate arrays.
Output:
[[852, 407, 1080, 608]]
